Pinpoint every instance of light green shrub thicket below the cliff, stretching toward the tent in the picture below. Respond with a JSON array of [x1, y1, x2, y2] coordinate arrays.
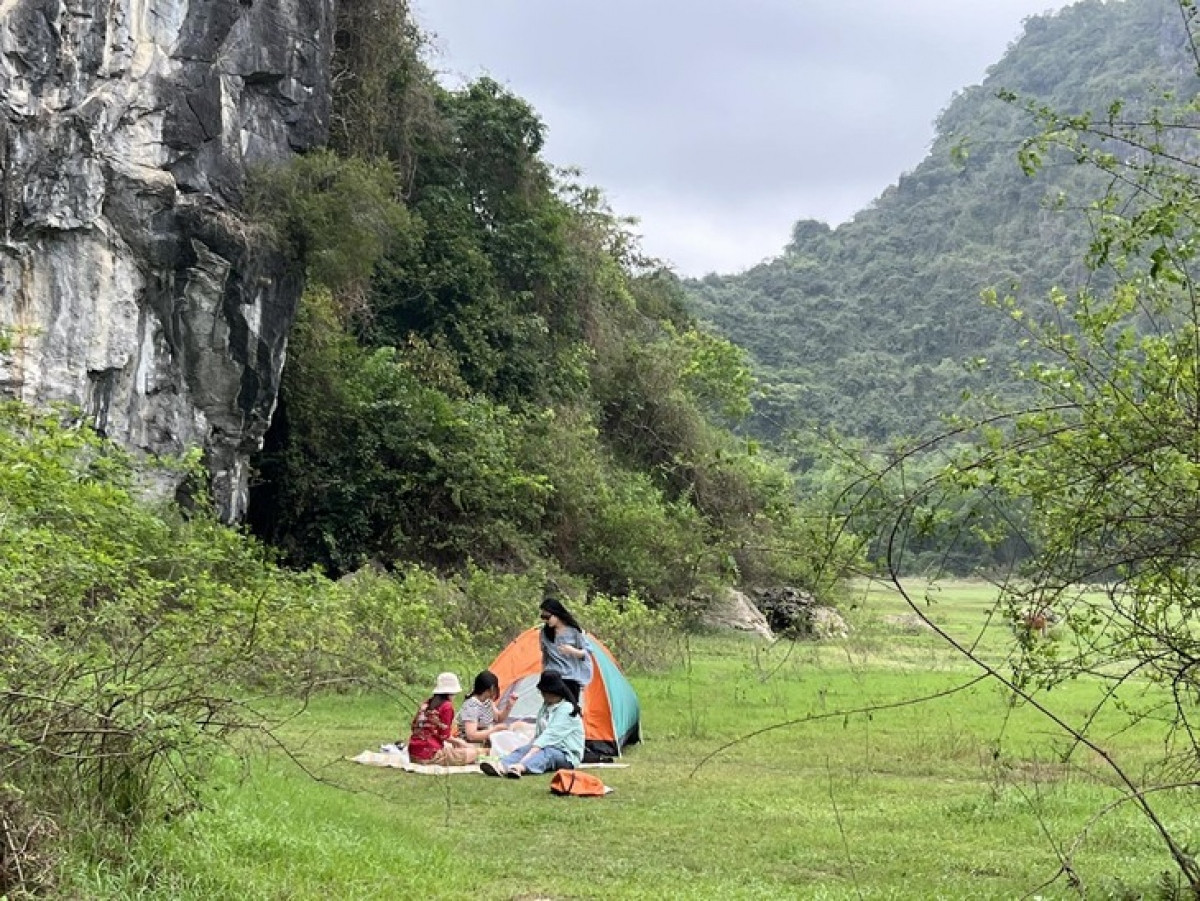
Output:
[[0, 404, 472, 893]]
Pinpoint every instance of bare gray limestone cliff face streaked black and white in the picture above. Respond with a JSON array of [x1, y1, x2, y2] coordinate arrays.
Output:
[[0, 0, 335, 519]]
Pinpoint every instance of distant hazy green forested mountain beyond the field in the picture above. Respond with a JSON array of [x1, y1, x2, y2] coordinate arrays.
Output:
[[686, 0, 1194, 440]]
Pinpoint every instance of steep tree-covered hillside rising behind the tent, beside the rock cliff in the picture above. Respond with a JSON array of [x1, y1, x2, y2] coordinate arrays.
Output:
[[238, 0, 836, 599]]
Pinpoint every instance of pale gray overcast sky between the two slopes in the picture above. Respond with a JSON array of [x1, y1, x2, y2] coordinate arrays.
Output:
[[413, 0, 1068, 276]]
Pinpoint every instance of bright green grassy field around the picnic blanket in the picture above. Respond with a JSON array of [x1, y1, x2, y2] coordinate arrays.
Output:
[[72, 584, 1200, 900]]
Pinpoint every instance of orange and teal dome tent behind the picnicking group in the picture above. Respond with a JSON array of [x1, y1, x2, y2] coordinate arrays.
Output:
[[488, 629, 642, 761]]
